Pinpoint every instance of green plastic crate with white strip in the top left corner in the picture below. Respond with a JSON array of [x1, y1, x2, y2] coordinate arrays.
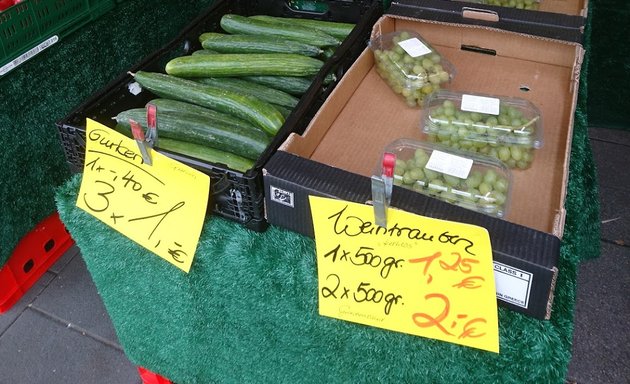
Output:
[[0, 0, 116, 77]]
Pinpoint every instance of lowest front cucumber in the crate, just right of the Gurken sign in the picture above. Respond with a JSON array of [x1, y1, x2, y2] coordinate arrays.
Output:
[[158, 138, 254, 173]]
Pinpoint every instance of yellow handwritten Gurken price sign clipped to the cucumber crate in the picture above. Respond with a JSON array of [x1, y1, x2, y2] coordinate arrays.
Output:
[[77, 119, 210, 272]]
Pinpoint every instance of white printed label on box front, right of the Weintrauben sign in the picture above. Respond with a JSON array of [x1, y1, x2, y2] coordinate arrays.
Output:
[[493, 261, 534, 308]]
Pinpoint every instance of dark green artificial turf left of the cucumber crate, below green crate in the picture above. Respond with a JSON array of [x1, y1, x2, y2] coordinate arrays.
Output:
[[0, 0, 212, 267]]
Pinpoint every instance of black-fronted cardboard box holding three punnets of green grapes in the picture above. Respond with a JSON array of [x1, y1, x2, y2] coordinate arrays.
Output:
[[263, 14, 584, 319]]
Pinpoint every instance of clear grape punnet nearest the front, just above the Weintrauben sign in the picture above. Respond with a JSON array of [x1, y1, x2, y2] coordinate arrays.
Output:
[[383, 139, 512, 218]]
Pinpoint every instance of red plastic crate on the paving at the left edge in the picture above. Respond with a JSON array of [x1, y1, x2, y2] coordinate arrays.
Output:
[[0, 213, 74, 314]]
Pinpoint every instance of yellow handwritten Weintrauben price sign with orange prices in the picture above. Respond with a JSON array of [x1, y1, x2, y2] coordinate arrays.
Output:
[[310, 196, 499, 353]]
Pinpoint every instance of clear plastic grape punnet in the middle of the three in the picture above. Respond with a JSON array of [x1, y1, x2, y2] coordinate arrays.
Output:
[[421, 90, 543, 169]]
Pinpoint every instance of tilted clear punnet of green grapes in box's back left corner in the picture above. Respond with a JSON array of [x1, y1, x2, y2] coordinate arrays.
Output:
[[369, 31, 455, 107]]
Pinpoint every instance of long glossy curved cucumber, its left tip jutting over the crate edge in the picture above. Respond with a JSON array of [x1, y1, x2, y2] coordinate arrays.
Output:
[[133, 71, 284, 136]]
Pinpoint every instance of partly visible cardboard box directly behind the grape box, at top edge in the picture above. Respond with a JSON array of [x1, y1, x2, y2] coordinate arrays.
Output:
[[388, 0, 588, 44]]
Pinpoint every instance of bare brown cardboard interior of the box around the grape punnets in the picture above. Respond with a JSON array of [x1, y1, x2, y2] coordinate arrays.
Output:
[[282, 15, 583, 237]]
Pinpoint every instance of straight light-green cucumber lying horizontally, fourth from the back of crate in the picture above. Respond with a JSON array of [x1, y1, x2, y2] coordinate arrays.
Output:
[[165, 53, 324, 78]]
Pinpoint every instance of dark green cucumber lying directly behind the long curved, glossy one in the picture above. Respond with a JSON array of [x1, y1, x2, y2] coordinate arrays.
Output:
[[196, 77, 300, 108]]
